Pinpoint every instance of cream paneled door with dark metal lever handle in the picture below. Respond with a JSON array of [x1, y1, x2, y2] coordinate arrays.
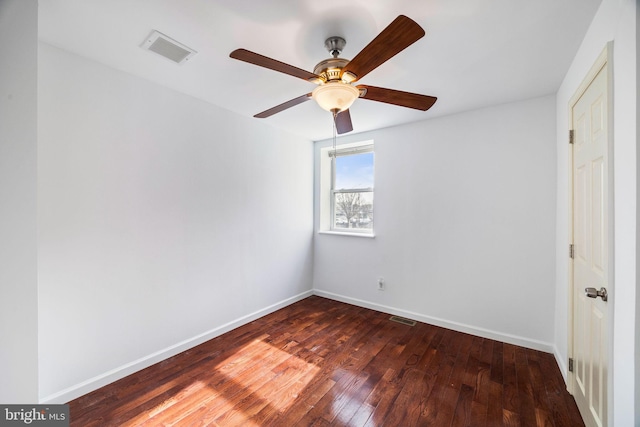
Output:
[[571, 51, 610, 427]]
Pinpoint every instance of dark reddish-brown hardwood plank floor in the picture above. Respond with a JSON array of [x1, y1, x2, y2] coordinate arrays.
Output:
[[69, 296, 584, 427]]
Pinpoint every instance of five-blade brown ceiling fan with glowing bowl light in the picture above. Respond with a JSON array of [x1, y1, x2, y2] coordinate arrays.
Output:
[[229, 15, 437, 134]]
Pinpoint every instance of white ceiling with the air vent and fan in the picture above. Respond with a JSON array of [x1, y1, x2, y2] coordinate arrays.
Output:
[[39, 0, 601, 140]]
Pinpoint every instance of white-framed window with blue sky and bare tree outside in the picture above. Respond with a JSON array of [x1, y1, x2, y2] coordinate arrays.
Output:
[[321, 141, 374, 235]]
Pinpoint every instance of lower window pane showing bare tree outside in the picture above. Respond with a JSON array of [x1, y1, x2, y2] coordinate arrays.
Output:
[[333, 191, 373, 230]]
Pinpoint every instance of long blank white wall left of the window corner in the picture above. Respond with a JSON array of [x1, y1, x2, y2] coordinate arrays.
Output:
[[38, 44, 313, 402]]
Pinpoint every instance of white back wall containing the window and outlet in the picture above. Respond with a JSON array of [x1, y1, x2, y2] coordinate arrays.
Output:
[[314, 96, 556, 351]]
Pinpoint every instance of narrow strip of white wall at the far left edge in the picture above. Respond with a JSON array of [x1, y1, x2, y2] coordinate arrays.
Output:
[[0, 0, 38, 404]]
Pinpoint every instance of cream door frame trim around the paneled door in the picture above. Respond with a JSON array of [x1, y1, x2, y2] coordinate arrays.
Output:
[[567, 41, 615, 426]]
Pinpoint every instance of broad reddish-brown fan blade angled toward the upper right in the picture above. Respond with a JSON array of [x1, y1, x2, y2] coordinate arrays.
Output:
[[342, 15, 425, 81]]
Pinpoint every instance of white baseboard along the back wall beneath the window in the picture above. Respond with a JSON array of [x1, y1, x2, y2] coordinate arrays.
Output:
[[313, 289, 562, 354]]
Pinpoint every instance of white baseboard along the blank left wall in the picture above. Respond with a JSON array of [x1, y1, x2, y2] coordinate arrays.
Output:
[[40, 290, 313, 404]]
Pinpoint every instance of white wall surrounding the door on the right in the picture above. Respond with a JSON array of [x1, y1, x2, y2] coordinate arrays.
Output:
[[555, 0, 640, 426]]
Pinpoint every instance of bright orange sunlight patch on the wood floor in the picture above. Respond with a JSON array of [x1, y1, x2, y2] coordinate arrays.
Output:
[[123, 336, 320, 426]]
